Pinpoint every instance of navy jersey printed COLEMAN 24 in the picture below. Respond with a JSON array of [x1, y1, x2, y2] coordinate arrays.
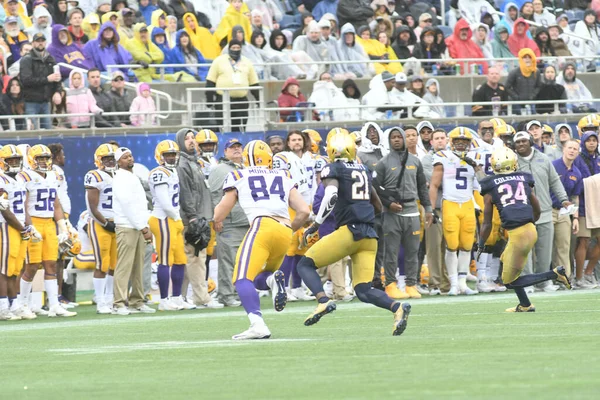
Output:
[[481, 172, 534, 229]]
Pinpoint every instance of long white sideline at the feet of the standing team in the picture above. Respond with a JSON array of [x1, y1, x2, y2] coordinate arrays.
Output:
[[0, 290, 600, 333]]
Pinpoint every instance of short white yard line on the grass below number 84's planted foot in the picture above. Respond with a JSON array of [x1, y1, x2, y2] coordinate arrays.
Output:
[[47, 339, 314, 356]]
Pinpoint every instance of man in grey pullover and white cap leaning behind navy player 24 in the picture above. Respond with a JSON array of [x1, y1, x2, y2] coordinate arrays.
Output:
[[514, 131, 571, 291]]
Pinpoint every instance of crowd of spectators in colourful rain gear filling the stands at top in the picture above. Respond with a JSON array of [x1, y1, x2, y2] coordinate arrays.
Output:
[[0, 0, 600, 129]]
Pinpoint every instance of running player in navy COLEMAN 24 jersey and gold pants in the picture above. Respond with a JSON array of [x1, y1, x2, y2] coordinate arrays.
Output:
[[478, 147, 571, 312]]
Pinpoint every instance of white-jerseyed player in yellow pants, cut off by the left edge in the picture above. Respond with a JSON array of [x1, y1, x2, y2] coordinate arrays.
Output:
[[0, 144, 41, 321]]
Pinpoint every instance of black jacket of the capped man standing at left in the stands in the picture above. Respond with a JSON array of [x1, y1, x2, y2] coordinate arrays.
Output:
[[19, 50, 61, 103]]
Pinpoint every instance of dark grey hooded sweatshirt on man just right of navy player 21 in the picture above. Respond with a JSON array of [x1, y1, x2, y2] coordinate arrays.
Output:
[[373, 127, 432, 216]]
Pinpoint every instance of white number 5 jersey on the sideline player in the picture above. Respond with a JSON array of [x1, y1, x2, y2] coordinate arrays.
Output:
[[432, 150, 481, 204]]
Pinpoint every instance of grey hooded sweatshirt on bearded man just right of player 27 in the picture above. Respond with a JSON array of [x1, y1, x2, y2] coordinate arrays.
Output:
[[175, 128, 213, 226]]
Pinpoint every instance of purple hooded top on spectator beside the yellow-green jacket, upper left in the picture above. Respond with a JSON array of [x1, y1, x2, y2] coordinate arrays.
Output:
[[83, 22, 132, 74]]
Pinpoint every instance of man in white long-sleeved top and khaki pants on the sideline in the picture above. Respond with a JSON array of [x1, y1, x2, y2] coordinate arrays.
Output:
[[112, 147, 156, 315]]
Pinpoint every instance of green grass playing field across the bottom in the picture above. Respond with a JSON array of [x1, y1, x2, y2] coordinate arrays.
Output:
[[0, 291, 600, 399]]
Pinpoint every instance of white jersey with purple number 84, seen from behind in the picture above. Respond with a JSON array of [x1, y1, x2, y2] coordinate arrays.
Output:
[[223, 167, 296, 223]]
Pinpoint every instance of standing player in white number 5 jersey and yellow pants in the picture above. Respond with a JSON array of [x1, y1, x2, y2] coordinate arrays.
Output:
[[429, 127, 480, 296]]
